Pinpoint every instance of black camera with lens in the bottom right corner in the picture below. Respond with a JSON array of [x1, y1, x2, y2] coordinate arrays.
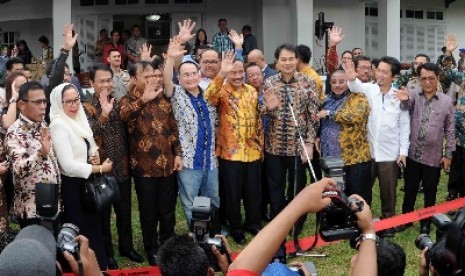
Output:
[[415, 208, 465, 276]]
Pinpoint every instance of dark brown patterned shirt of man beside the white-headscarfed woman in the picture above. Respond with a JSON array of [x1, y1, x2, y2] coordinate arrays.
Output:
[[84, 93, 130, 182]]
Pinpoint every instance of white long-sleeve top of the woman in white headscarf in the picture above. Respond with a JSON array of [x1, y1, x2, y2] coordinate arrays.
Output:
[[50, 119, 98, 179]]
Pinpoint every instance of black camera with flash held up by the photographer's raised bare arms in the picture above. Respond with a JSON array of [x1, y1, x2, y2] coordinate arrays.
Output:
[[319, 156, 363, 241]]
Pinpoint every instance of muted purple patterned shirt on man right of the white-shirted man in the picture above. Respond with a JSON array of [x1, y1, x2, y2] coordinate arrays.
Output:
[[402, 87, 455, 167]]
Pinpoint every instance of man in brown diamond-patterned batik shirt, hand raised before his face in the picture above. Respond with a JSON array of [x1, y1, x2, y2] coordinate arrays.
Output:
[[120, 62, 182, 266]]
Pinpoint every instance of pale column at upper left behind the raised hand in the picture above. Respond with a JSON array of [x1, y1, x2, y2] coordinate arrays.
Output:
[[52, 0, 73, 68]]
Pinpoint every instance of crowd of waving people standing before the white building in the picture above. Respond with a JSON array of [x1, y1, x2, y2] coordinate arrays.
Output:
[[0, 16, 465, 275]]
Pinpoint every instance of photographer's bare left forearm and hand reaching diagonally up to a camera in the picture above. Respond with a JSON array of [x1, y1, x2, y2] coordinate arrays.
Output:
[[229, 178, 334, 275]]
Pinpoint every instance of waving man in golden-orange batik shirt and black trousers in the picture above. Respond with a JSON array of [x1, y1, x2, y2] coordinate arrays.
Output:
[[205, 51, 263, 244]]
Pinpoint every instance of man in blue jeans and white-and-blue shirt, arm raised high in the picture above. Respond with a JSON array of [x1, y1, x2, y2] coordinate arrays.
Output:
[[163, 37, 220, 230]]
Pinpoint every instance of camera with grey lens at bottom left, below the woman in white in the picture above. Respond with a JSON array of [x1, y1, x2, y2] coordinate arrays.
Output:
[[57, 223, 80, 272]]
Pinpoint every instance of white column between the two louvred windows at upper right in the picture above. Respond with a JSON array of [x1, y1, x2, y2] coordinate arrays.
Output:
[[378, 0, 400, 59]]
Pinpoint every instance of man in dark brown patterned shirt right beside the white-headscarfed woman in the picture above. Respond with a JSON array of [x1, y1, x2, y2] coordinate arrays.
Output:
[[84, 64, 144, 269]]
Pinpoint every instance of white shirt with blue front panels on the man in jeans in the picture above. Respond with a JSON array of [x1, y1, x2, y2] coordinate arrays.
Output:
[[171, 85, 218, 170]]
